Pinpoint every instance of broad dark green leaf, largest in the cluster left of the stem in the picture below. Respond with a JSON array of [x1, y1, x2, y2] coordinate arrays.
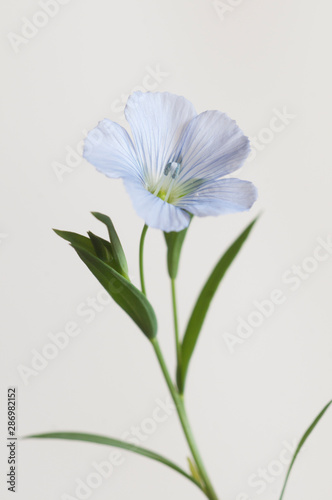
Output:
[[72, 244, 157, 339]]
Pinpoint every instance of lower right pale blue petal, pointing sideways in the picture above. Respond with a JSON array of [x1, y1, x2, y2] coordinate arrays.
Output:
[[176, 178, 257, 217]]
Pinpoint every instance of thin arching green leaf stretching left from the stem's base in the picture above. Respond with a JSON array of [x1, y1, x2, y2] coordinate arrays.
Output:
[[24, 432, 202, 489]]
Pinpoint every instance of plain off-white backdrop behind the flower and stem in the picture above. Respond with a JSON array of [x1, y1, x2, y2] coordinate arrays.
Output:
[[0, 0, 332, 500]]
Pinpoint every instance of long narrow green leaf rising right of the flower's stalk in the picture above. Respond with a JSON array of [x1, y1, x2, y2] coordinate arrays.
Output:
[[177, 218, 257, 393]]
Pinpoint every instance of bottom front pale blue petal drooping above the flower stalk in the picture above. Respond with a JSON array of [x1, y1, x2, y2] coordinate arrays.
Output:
[[124, 179, 190, 232]]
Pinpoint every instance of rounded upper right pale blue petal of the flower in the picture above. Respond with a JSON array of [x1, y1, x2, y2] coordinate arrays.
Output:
[[175, 111, 250, 183]]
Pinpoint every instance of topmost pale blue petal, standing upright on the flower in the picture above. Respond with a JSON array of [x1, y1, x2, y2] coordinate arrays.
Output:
[[125, 92, 197, 183]]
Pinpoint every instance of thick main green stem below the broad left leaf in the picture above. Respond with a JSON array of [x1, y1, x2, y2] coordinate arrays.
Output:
[[151, 337, 218, 500]]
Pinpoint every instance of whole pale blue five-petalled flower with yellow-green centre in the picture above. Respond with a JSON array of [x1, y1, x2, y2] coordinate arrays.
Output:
[[84, 92, 257, 232]]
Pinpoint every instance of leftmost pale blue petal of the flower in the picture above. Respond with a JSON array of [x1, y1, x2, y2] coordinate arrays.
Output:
[[83, 119, 142, 179]]
